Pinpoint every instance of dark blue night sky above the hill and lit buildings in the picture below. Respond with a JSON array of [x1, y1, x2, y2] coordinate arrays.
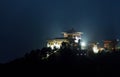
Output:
[[0, 0, 120, 62]]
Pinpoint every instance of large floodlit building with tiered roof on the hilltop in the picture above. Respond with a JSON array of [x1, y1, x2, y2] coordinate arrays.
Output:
[[47, 29, 85, 49]]
